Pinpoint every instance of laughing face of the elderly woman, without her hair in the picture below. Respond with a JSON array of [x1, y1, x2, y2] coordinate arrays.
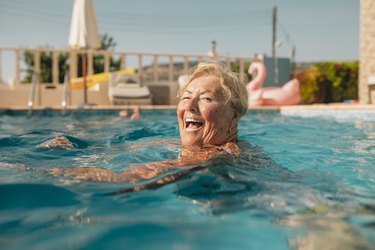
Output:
[[177, 76, 237, 146]]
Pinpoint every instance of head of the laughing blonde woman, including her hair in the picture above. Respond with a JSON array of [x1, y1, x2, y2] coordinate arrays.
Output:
[[177, 63, 247, 146]]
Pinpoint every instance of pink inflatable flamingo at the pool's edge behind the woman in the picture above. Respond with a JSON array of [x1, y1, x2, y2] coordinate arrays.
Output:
[[246, 62, 301, 108]]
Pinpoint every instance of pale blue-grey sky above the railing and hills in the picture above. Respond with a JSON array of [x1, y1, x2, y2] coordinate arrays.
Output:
[[0, 0, 359, 80]]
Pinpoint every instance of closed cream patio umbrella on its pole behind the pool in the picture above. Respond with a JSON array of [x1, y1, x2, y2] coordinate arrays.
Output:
[[68, 0, 100, 104]]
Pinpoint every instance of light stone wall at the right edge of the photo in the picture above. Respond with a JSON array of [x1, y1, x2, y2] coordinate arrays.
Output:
[[358, 0, 375, 104]]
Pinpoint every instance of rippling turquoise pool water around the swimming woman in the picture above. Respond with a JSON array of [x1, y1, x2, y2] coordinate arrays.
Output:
[[0, 110, 375, 250]]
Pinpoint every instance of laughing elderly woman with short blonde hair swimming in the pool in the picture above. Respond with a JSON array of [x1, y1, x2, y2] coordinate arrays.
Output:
[[49, 63, 247, 184]]
